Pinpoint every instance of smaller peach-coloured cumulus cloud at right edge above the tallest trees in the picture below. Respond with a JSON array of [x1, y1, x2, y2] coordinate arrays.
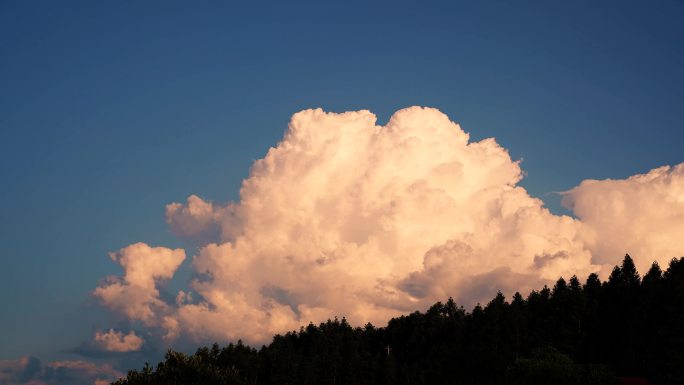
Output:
[[562, 163, 684, 271]]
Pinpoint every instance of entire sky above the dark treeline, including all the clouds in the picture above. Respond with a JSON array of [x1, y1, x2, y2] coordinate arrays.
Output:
[[0, 1, 684, 384]]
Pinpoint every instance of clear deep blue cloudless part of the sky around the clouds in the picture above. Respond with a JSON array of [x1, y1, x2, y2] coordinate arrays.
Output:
[[0, 1, 684, 360]]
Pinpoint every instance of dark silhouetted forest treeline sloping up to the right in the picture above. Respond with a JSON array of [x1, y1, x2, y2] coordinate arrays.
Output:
[[115, 255, 684, 385]]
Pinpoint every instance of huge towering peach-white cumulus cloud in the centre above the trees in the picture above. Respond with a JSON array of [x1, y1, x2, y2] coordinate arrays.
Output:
[[95, 107, 683, 343]]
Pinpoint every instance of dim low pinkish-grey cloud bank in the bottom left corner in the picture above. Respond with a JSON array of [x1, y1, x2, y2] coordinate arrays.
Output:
[[0, 356, 122, 385]]
